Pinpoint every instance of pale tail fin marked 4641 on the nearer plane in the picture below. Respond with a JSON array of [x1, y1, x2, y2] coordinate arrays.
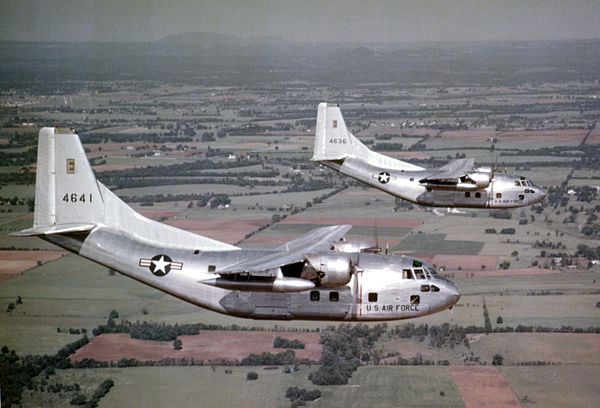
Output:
[[14, 128, 237, 250]]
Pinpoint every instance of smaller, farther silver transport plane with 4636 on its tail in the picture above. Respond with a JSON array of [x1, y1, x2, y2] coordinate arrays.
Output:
[[312, 103, 545, 208]]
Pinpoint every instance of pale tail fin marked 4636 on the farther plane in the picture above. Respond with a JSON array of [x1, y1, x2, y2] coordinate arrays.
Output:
[[311, 102, 424, 170]]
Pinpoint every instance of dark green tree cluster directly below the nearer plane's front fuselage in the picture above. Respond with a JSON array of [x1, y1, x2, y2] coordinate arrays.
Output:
[[308, 324, 387, 385]]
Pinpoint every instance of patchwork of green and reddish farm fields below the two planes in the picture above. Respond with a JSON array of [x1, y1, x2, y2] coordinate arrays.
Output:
[[0, 37, 600, 407]]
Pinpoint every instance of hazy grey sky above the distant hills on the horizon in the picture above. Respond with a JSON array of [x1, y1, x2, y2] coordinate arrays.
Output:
[[0, 0, 600, 42]]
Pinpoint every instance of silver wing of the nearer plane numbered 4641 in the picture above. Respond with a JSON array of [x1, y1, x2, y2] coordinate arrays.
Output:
[[215, 225, 352, 277]]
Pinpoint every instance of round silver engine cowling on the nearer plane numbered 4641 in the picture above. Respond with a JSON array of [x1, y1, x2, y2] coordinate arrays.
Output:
[[303, 254, 352, 286]]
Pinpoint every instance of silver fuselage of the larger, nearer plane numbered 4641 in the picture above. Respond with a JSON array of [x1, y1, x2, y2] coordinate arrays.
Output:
[[46, 227, 460, 321]]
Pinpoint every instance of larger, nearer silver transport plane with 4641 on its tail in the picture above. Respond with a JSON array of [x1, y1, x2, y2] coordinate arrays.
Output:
[[15, 128, 460, 321]]
